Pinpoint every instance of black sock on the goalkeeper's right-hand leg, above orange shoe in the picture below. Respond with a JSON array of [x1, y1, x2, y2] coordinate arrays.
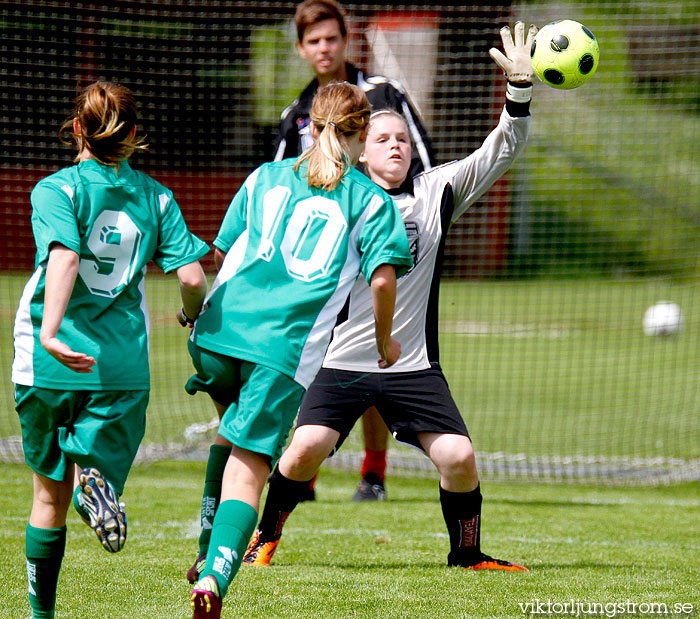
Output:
[[440, 486, 481, 565]]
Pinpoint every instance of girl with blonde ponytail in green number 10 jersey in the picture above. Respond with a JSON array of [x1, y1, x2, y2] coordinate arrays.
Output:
[[187, 82, 412, 619]]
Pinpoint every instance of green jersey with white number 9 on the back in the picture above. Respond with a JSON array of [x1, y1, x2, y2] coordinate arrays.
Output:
[[12, 159, 208, 390]]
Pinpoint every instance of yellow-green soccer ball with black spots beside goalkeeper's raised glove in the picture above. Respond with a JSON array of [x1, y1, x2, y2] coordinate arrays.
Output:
[[530, 19, 600, 90]]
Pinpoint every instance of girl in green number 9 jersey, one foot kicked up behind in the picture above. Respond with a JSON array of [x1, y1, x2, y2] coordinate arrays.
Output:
[[12, 82, 208, 619]]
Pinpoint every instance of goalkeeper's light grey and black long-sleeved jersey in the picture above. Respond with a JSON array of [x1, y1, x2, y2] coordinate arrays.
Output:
[[323, 102, 530, 372]]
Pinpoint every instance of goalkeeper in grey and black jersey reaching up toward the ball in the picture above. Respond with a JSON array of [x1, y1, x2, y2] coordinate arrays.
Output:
[[244, 22, 537, 571]]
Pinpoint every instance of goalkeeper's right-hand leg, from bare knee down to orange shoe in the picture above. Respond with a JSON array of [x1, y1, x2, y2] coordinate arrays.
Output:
[[418, 432, 528, 572]]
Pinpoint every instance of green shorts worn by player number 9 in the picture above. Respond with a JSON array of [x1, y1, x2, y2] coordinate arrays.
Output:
[[15, 385, 149, 494]]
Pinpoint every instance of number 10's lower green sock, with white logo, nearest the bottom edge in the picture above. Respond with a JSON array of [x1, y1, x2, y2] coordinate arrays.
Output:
[[200, 501, 258, 598]]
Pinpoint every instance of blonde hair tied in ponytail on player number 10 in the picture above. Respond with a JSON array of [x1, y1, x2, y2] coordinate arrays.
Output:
[[294, 82, 371, 191]]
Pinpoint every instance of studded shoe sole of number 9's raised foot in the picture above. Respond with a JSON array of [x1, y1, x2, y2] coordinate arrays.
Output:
[[78, 467, 126, 552]]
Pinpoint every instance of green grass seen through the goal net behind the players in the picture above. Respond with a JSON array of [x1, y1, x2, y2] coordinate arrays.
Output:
[[0, 276, 700, 484]]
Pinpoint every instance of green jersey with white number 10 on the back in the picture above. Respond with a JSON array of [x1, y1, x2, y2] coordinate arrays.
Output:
[[192, 159, 412, 388]]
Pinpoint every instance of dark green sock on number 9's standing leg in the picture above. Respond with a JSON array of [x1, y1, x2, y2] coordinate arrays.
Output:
[[25, 524, 66, 619]]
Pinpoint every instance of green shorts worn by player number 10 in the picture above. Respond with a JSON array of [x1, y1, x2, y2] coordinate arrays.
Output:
[[185, 341, 304, 467]]
